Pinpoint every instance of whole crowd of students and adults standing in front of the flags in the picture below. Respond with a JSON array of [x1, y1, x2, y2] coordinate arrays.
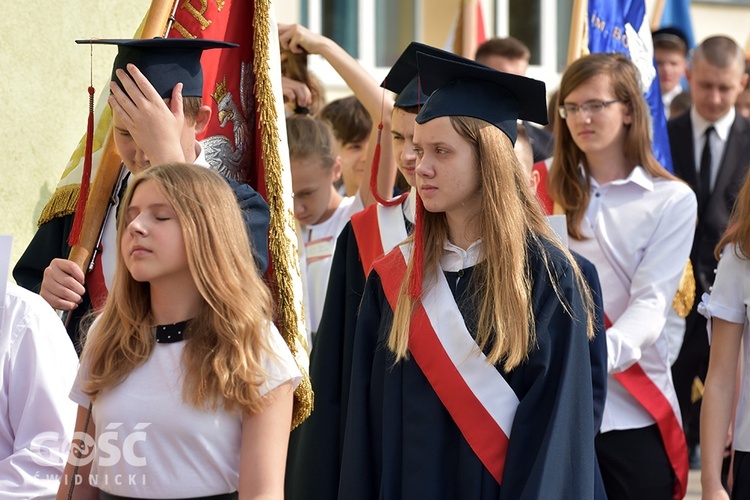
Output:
[[0, 14, 750, 499]]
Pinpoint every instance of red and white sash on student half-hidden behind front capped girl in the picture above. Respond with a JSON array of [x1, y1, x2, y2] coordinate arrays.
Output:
[[351, 193, 409, 276]]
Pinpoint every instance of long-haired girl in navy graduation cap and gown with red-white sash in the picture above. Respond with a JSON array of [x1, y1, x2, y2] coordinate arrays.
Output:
[[338, 52, 594, 499]]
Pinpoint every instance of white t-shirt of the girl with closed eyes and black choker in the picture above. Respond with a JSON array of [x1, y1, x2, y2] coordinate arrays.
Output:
[[70, 324, 301, 498]]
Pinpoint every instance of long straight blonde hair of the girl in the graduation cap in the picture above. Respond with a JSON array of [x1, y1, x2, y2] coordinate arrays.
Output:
[[388, 116, 593, 371]]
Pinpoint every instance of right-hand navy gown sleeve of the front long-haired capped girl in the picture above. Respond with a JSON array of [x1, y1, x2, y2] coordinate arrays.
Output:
[[500, 247, 595, 499]]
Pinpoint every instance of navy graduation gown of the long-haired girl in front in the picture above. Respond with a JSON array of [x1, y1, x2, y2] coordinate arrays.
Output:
[[338, 240, 594, 499]]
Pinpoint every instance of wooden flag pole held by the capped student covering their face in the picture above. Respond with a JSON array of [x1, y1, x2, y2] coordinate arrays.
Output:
[[68, 0, 176, 273]]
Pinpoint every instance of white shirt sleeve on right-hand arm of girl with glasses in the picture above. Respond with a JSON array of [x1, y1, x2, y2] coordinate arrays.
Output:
[[607, 188, 697, 373]]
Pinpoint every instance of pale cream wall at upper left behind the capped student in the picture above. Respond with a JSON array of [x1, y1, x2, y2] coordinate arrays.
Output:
[[0, 0, 151, 279]]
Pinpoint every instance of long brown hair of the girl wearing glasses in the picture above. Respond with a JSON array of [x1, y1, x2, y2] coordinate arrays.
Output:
[[547, 54, 676, 240]]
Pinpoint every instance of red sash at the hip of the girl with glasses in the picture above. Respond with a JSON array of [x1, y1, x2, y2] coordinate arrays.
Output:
[[604, 314, 689, 500]]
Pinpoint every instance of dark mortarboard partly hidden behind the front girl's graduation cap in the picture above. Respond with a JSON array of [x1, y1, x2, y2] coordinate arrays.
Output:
[[380, 42, 478, 108]]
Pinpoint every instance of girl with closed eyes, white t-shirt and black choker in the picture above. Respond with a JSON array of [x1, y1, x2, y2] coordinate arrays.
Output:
[[58, 164, 300, 499]]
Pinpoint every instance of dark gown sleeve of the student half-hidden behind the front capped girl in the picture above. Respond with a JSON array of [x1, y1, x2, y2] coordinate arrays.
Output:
[[286, 223, 365, 500]]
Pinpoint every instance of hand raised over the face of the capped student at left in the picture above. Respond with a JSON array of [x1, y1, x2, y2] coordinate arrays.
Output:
[[109, 64, 192, 165]]
